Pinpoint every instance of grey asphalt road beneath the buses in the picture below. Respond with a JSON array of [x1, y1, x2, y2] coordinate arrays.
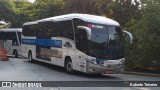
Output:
[[0, 58, 160, 90]]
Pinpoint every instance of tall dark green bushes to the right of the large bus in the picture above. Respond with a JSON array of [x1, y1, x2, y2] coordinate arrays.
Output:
[[126, 0, 160, 71]]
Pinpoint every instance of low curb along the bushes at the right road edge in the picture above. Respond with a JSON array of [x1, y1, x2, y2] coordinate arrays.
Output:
[[122, 71, 160, 77]]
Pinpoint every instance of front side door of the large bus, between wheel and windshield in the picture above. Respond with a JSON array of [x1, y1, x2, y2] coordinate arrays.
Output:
[[75, 28, 88, 72]]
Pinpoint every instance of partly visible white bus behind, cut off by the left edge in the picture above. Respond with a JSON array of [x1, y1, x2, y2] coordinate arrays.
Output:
[[0, 28, 22, 58]]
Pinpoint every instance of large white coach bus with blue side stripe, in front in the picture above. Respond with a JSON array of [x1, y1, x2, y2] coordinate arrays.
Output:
[[21, 13, 133, 74]]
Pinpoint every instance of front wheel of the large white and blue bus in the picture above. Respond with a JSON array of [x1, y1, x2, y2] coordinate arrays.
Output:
[[65, 59, 73, 74]]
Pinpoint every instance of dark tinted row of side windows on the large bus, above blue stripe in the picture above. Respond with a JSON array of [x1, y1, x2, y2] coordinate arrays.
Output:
[[22, 20, 74, 39]]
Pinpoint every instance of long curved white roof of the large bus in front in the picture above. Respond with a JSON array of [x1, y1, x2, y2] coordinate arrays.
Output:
[[24, 13, 120, 26]]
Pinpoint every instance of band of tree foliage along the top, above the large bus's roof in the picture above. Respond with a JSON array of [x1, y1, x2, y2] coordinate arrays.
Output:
[[0, 0, 139, 27]]
